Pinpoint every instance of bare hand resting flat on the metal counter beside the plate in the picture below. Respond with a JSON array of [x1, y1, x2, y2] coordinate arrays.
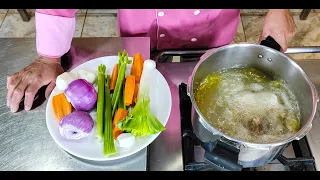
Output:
[[7, 57, 64, 112]]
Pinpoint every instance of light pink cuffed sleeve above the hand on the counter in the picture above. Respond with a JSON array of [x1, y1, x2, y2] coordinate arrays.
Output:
[[35, 9, 77, 59]]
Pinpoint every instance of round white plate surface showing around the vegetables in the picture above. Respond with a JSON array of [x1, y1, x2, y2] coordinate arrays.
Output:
[[46, 56, 172, 161]]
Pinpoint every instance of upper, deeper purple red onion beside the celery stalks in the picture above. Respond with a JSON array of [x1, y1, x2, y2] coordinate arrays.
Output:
[[64, 79, 98, 112]]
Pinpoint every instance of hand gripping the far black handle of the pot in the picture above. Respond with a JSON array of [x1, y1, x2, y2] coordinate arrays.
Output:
[[259, 9, 297, 52]]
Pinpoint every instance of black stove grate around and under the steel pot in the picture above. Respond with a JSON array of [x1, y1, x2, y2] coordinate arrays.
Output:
[[179, 83, 316, 171]]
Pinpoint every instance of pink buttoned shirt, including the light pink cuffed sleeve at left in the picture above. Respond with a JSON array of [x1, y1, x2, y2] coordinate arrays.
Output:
[[36, 9, 240, 57]]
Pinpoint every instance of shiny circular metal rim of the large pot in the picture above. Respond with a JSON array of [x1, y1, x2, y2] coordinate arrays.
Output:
[[188, 43, 319, 147]]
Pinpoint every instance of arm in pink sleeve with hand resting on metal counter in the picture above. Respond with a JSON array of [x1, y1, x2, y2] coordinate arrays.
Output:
[[7, 9, 77, 112]]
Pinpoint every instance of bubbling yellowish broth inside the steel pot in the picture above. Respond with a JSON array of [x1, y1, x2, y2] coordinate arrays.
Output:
[[195, 68, 300, 143]]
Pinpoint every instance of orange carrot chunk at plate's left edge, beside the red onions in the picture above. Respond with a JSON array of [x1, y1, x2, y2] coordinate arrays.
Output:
[[52, 93, 72, 121]]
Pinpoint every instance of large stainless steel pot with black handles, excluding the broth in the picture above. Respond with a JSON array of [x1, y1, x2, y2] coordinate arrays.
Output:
[[188, 37, 318, 170]]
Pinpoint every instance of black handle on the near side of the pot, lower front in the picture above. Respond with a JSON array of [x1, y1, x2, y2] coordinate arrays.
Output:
[[202, 140, 242, 171]]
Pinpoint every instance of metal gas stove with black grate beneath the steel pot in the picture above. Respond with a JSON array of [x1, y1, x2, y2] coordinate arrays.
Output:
[[146, 48, 320, 171]]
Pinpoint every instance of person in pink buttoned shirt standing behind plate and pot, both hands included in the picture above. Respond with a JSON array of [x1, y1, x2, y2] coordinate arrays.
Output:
[[7, 9, 296, 112]]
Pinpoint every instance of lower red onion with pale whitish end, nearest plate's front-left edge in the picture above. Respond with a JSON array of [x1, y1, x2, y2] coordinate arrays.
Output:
[[59, 111, 94, 140]]
